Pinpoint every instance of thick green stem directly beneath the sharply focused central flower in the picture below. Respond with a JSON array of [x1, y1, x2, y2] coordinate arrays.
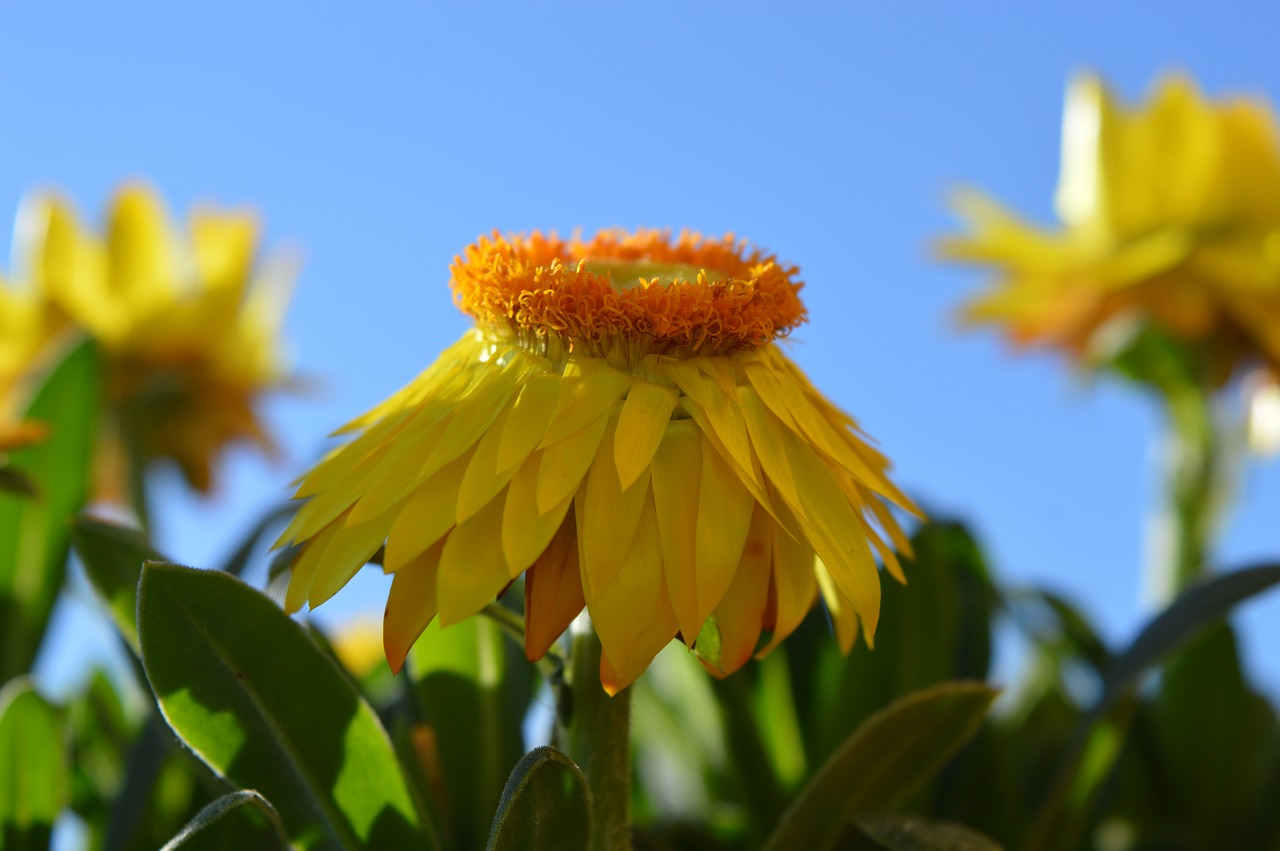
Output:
[[557, 616, 631, 851]]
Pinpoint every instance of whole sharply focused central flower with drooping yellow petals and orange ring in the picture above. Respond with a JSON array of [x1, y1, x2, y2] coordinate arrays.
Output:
[[280, 230, 914, 692]]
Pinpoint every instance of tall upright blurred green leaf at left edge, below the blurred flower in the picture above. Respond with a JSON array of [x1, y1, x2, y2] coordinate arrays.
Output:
[[0, 343, 101, 682]]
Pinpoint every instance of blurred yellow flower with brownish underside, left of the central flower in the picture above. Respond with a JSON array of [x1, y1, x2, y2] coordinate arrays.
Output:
[[17, 186, 293, 499]]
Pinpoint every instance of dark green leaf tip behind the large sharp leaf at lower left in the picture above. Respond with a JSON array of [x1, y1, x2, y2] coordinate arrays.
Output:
[[72, 517, 160, 655]]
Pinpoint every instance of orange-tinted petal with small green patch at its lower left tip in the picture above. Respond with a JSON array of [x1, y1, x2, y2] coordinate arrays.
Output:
[[703, 505, 768, 677]]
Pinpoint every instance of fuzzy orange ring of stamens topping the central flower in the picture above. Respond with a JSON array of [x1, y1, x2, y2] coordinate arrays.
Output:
[[451, 230, 805, 353]]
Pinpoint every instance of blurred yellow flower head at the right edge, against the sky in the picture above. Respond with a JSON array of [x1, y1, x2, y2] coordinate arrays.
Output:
[[943, 77, 1280, 381]]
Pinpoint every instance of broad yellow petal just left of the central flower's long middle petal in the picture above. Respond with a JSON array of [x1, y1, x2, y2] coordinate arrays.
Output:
[[577, 417, 660, 594]]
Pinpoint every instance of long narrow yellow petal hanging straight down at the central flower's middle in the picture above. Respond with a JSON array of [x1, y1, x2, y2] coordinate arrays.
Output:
[[652, 420, 703, 646]]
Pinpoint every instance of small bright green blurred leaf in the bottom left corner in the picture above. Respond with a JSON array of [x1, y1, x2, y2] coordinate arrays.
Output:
[[0, 678, 70, 851]]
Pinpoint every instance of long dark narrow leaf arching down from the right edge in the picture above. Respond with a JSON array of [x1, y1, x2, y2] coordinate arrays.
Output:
[[1025, 564, 1280, 851]]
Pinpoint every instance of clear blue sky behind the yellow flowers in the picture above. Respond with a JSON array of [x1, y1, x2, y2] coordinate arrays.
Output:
[[0, 0, 1280, 694]]
